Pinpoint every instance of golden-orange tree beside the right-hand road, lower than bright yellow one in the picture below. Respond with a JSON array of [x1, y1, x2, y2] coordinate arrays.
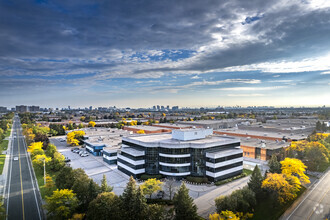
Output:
[[261, 173, 300, 204]]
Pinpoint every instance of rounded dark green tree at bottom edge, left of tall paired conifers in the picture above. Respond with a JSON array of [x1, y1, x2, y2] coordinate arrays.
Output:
[[87, 192, 122, 220]]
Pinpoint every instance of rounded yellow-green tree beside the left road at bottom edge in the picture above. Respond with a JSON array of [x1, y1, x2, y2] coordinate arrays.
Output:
[[45, 189, 78, 219]]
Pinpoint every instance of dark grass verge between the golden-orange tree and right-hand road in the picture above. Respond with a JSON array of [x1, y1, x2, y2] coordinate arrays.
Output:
[[252, 186, 306, 220]]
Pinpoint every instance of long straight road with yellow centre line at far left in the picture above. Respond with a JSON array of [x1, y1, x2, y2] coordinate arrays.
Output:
[[5, 116, 43, 220]]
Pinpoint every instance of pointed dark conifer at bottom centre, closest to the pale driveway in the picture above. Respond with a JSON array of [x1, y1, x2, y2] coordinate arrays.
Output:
[[173, 183, 199, 220]]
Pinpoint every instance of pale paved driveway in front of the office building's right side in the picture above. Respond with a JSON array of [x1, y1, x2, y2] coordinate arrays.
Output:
[[194, 176, 250, 219]]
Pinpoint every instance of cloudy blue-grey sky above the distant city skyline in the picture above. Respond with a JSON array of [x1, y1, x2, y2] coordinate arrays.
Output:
[[0, 0, 330, 107]]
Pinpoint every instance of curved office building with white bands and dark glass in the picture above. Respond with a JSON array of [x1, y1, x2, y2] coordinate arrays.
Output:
[[117, 129, 243, 181]]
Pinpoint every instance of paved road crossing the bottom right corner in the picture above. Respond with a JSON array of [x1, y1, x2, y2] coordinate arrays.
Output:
[[281, 170, 330, 220]]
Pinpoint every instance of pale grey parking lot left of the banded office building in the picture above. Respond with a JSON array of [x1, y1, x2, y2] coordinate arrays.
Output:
[[50, 136, 129, 195]]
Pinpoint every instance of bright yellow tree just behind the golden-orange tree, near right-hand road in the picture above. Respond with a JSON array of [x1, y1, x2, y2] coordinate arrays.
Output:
[[281, 157, 310, 185]]
